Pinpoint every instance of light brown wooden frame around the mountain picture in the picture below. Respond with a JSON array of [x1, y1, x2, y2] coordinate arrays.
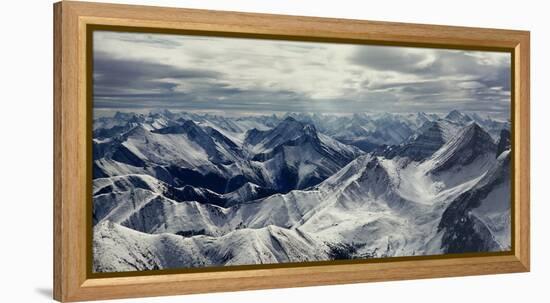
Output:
[[53, 1, 530, 302]]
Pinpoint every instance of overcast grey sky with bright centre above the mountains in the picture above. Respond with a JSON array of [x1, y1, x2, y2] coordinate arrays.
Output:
[[93, 31, 510, 117]]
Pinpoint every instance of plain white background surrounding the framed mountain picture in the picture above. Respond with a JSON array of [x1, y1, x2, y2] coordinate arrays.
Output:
[[0, 0, 550, 303]]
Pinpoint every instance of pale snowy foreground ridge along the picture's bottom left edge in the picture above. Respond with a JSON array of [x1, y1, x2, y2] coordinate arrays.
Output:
[[93, 221, 328, 272]]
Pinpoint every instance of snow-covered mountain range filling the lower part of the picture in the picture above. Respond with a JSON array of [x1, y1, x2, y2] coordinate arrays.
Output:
[[93, 110, 511, 272]]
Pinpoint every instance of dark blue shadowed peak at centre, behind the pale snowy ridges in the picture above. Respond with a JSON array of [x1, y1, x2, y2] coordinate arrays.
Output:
[[245, 117, 362, 192]]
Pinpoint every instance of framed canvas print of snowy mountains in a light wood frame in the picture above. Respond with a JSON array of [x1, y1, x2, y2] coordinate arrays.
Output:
[[54, 1, 530, 301]]
